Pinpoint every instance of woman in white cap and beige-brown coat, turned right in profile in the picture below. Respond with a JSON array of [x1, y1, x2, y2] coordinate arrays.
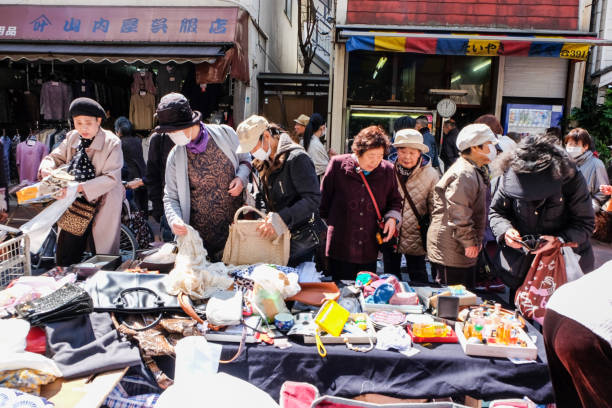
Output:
[[427, 123, 497, 287]]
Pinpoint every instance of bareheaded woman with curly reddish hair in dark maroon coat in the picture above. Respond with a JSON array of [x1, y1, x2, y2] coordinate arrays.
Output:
[[320, 126, 402, 280]]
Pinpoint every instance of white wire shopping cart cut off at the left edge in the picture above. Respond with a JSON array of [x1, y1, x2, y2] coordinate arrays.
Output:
[[0, 225, 32, 289]]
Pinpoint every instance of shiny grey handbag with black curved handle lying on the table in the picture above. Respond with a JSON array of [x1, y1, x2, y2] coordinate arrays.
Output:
[[85, 271, 183, 330]]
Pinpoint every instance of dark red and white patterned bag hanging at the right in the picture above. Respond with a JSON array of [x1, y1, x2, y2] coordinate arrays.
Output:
[[514, 240, 578, 324]]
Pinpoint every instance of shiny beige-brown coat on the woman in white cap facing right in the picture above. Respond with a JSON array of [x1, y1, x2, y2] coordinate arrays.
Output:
[[427, 157, 488, 268]]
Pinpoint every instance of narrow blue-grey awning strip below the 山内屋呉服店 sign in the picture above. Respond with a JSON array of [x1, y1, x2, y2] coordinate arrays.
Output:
[[0, 43, 227, 64]]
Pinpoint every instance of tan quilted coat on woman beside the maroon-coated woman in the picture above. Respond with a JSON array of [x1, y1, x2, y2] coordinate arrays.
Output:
[[396, 156, 440, 256]]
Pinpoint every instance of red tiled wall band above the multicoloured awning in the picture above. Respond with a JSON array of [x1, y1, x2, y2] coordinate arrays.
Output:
[[346, 0, 579, 30]]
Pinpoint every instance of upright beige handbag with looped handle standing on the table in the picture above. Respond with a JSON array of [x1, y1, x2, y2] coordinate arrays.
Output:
[[223, 206, 291, 266]]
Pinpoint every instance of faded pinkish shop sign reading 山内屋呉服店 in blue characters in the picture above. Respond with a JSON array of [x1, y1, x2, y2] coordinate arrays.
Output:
[[0, 6, 238, 43]]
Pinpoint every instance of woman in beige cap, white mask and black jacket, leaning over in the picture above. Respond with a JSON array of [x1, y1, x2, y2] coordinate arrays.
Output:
[[237, 115, 322, 266]]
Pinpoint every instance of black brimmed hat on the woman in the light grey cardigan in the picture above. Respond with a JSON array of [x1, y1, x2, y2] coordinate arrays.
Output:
[[155, 92, 202, 133]]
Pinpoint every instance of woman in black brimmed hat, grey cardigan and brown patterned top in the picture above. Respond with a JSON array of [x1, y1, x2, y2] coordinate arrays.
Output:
[[161, 93, 251, 261]]
